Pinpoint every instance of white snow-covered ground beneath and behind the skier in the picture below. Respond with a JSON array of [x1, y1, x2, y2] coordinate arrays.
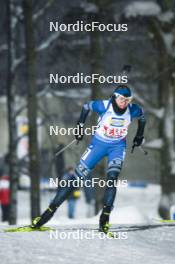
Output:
[[0, 185, 175, 264]]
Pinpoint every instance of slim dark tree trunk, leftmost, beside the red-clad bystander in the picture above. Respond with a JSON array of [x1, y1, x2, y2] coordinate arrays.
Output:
[[6, 0, 18, 225]]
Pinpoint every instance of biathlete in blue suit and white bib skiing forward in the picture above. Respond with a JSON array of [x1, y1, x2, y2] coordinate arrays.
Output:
[[31, 85, 146, 233]]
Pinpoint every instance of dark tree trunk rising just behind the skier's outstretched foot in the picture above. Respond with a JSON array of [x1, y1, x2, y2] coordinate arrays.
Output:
[[23, 0, 40, 218]]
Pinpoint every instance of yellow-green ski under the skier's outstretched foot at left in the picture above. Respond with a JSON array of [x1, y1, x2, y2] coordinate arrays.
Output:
[[4, 225, 55, 232]]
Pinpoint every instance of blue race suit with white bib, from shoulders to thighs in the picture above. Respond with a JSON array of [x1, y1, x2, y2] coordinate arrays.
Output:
[[80, 100, 143, 170]]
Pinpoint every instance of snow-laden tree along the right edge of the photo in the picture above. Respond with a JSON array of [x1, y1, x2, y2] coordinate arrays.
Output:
[[125, 0, 175, 219]]
